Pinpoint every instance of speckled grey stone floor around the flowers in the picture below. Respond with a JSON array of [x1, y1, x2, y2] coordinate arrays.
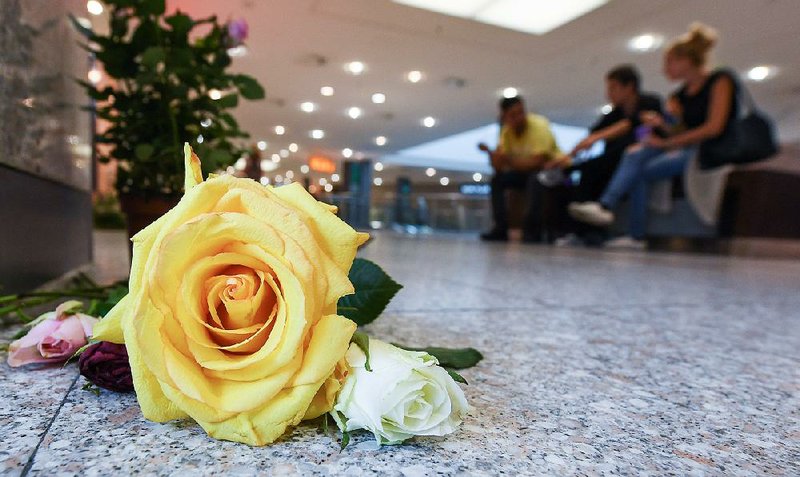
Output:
[[0, 233, 800, 476]]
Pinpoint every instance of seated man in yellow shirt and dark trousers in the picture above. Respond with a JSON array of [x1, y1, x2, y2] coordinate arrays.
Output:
[[479, 96, 564, 242]]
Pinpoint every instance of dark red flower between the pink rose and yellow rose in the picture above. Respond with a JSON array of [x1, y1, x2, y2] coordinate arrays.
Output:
[[78, 341, 133, 393]]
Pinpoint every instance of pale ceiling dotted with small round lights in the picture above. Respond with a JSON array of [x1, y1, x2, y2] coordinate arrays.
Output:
[[168, 0, 800, 177]]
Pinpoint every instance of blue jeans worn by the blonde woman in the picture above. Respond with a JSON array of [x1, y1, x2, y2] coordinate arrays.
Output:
[[600, 146, 694, 239]]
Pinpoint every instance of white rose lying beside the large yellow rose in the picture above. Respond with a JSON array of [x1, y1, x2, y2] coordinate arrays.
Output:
[[331, 339, 469, 444]]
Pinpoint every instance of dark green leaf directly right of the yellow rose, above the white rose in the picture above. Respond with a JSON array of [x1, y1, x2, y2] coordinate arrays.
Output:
[[338, 258, 403, 326]]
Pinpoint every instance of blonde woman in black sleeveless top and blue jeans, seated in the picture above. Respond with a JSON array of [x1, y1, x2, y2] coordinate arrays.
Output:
[[569, 23, 738, 248]]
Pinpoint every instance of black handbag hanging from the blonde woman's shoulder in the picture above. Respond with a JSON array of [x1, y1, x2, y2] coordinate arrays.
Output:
[[699, 72, 778, 170]]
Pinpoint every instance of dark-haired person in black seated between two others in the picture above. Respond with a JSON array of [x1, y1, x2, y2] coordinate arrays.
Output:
[[548, 65, 661, 244]]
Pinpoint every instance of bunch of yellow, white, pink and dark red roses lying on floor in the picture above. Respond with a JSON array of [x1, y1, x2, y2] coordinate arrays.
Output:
[[0, 144, 481, 447]]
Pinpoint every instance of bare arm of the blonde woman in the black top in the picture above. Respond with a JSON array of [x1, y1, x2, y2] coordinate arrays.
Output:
[[647, 76, 734, 148]]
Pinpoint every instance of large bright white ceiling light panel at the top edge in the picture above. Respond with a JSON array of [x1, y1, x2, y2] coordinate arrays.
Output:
[[394, 0, 608, 35]]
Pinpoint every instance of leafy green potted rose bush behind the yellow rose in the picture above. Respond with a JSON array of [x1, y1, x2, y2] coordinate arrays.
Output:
[[71, 0, 264, 235]]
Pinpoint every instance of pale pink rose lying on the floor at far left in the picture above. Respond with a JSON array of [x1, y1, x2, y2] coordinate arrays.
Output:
[[8, 301, 98, 367]]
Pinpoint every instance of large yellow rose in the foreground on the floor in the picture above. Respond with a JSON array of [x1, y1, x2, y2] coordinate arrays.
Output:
[[94, 145, 368, 445]]
